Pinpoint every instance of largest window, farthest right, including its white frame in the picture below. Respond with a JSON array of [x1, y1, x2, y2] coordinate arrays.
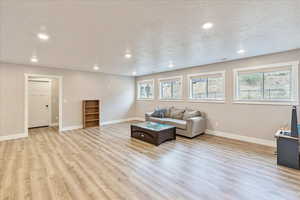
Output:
[[234, 62, 298, 104]]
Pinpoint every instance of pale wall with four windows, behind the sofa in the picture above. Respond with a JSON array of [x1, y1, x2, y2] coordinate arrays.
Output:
[[136, 50, 300, 140]]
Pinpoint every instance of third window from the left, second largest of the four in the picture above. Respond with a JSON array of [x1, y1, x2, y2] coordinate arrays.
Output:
[[188, 71, 225, 101]]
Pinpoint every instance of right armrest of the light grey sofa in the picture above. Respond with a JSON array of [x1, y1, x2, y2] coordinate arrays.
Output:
[[186, 117, 206, 135]]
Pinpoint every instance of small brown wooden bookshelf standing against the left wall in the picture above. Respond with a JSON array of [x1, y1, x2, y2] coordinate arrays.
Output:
[[82, 100, 100, 128]]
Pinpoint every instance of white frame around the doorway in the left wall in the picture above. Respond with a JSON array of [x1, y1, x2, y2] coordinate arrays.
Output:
[[24, 73, 63, 137]]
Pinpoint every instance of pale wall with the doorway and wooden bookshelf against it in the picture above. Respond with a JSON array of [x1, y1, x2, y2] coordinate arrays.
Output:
[[0, 63, 135, 136]]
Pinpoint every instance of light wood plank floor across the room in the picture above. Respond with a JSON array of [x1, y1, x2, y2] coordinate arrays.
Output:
[[0, 123, 300, 200]]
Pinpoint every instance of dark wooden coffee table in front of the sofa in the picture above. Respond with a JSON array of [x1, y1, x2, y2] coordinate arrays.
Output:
[[131, 122, 176, 146]]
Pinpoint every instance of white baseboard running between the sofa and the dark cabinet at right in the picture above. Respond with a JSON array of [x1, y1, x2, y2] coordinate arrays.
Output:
[[205, 129, 276, 147]]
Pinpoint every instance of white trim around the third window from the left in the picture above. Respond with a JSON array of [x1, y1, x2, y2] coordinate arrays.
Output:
[[187, 70, 226, 103]]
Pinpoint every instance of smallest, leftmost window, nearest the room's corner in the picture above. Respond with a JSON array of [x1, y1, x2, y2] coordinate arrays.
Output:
[[137, 80, 154, 100]]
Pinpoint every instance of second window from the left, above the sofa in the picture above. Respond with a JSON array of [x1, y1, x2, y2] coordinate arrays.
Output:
[[159, 76, 182, 100]]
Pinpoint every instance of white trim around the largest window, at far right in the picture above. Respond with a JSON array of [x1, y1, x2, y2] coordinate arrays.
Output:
[[232, 61, 299, 105]]
